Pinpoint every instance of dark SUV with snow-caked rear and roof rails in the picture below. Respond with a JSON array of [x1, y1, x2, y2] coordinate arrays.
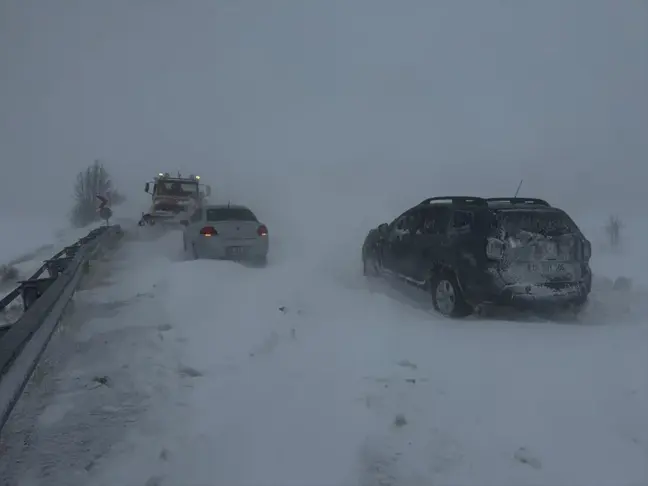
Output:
[[362, 196, 592, 317]]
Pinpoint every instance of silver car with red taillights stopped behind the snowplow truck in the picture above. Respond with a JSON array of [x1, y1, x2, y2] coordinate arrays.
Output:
[[181, 204, 269, 265]]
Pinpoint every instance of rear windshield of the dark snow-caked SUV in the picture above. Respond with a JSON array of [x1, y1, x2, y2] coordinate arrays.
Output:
[[497, 210, 578, 236]]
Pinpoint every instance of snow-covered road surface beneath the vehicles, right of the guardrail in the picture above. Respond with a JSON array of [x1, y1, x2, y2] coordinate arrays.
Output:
[[0, 224, 648, 486]]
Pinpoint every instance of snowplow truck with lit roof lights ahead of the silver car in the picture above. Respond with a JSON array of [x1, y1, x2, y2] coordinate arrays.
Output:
[[139, 172, 211, 226]]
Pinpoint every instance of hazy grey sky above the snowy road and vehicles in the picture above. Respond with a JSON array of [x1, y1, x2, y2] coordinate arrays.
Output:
[[0, 0, 648, 220]]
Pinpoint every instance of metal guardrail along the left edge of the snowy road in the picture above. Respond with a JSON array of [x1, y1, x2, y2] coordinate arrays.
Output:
[[0, 225, 123, 431]]
